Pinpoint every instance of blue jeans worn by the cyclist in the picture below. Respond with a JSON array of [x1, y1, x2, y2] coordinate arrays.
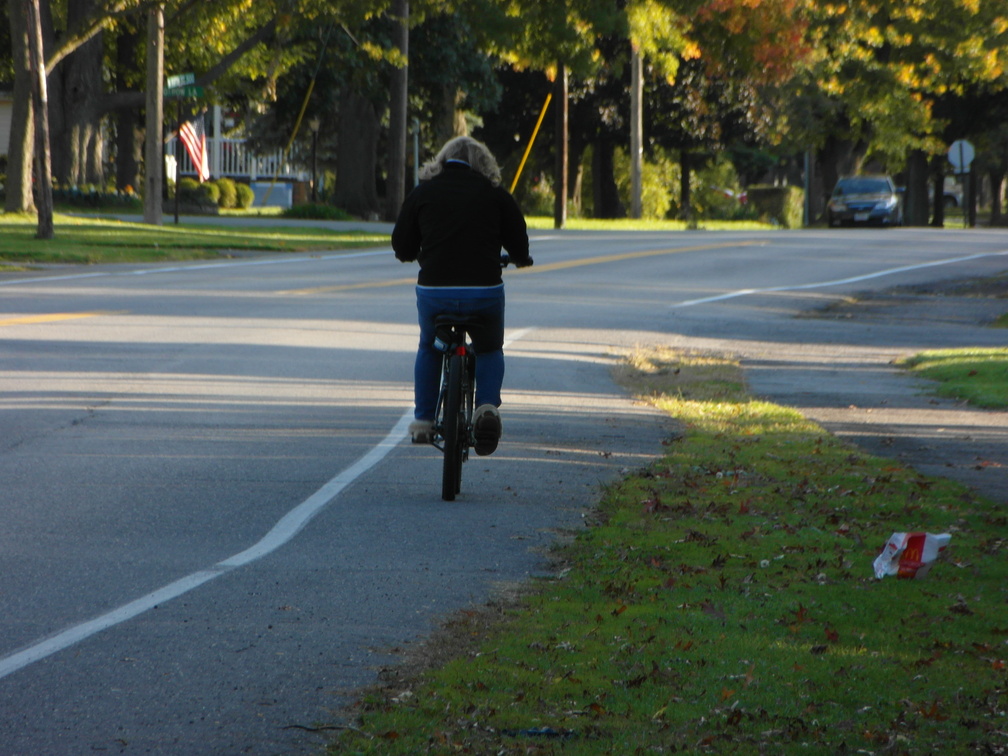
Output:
[[413, 284, 504, 420]]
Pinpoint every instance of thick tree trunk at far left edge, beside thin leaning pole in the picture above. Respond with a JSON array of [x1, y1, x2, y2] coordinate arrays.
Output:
[[4, 0, 35, 213]]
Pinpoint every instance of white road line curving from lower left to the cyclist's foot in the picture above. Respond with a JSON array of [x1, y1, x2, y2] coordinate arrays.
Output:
[[0, 409, 413, 678]]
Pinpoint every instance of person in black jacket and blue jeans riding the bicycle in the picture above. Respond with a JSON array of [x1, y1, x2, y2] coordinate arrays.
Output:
[[392, 136, 532, 456]]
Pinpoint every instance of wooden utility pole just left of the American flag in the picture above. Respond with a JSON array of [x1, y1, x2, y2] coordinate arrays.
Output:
[[143, 5, 163, 226]]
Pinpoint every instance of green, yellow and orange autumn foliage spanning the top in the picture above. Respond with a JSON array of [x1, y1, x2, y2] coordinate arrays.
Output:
[[7, 0, 1008, 223]]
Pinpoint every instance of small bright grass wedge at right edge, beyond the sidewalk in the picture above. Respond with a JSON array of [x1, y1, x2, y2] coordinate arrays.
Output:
[[900, 347, 1008, 409]]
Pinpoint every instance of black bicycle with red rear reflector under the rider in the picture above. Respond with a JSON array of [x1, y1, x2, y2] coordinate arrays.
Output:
[[431, 253, 524, 501]]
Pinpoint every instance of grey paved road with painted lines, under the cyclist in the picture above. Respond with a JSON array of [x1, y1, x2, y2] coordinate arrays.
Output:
[[0, 230, 1008, 754]]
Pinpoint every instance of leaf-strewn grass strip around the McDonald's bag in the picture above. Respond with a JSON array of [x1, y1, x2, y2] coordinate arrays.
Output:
[[332, 346, 1008, 754]]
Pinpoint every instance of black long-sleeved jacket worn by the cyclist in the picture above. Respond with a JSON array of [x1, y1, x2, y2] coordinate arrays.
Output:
[[392, 162, 528, 286]]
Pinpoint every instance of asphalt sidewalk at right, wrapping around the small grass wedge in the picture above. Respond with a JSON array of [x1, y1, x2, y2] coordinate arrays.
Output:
[[743, 290, 1008, 504]]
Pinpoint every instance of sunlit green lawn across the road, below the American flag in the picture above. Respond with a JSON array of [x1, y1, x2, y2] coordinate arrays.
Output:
[[0, 214, 388, 267]]
